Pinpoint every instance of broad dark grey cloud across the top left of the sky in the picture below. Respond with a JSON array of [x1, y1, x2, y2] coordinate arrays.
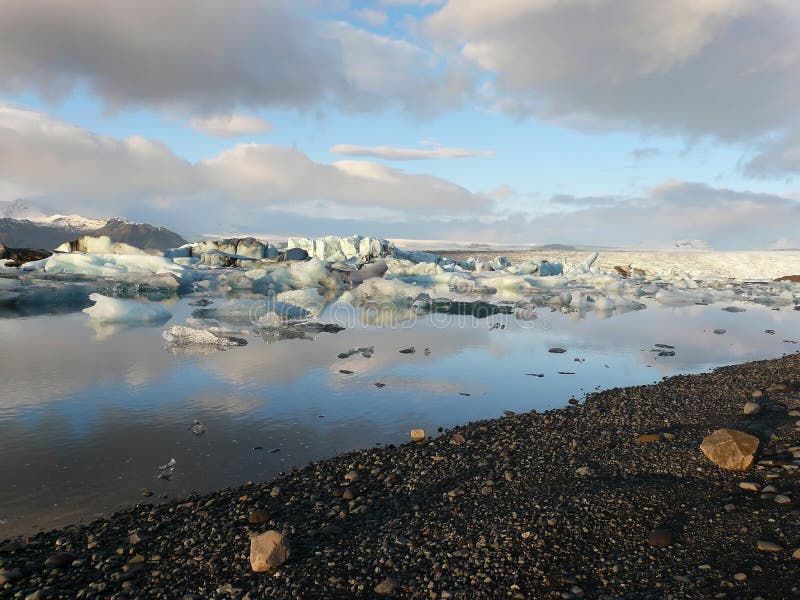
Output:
[[0, 0, 471, 115]]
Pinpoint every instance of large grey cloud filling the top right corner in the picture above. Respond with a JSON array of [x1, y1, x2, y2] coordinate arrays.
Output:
[[426, 0, 800, 140]]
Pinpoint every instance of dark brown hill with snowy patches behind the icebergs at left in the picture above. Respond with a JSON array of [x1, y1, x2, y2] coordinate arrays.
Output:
[[0, 218, 186, 250]]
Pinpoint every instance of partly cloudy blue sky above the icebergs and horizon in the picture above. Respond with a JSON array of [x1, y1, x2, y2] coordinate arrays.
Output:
[[0, 0, 800, 250]]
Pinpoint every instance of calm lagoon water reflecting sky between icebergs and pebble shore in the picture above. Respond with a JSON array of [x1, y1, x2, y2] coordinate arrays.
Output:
[[0, 300, 800, 538]]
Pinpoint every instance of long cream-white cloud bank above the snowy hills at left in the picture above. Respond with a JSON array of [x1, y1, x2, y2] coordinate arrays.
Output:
[[0, 105, 492, 218]]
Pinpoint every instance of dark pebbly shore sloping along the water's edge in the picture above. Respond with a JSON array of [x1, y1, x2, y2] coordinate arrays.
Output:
[[0, 355, 800, 599]]
